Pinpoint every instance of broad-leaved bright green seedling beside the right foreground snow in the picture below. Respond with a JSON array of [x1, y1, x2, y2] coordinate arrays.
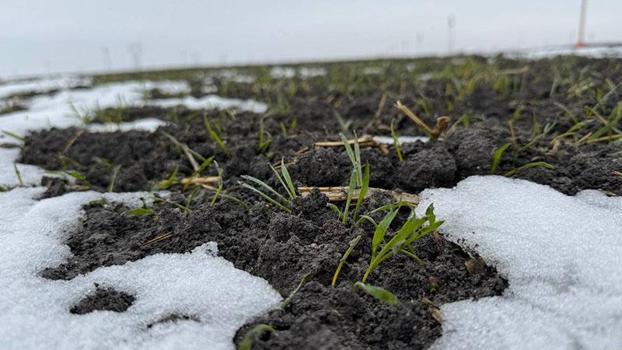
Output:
[[361, 205, 443, 283]]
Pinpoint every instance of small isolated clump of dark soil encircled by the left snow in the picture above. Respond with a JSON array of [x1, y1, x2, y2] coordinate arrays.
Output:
[[69, 284, 135, 315]]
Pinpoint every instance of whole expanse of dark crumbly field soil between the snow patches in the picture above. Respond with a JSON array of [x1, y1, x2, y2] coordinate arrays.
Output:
[[15, 58, 622, 349]]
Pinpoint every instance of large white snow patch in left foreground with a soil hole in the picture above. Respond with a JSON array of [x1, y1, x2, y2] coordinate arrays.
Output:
[[0, 187, 281, 350]]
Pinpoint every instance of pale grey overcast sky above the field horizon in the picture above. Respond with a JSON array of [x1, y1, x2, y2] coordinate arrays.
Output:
[[0, 0, 622, 76]]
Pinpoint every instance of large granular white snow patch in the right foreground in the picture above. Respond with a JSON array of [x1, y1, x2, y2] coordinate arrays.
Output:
[[418, 176, 622, 349]]
